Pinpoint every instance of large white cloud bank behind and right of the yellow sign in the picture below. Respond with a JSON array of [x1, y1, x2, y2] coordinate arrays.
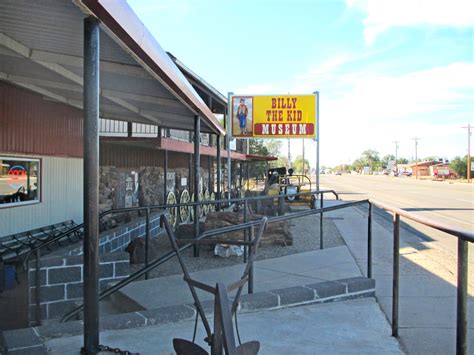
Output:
[[227, 54, 474, 166]]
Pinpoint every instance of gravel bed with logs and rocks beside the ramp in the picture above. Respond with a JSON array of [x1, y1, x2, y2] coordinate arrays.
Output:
[[131, 210, 345, 278]]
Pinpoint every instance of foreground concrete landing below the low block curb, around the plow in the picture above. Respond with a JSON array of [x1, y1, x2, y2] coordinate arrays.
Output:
[[46, 298, 402, 355]]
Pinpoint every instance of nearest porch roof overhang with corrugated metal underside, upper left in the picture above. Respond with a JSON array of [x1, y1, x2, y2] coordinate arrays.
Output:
[[0, 0, 225, 135]]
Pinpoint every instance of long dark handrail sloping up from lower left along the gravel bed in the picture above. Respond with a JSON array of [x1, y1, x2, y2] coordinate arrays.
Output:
[[60, 200, 369, 322]]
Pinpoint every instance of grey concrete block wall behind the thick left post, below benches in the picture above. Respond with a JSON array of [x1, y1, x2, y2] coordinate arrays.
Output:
[[28, 213, 165, 321]]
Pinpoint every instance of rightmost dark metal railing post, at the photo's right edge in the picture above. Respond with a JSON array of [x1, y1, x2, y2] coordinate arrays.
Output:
[[456, 237, 469, 355]]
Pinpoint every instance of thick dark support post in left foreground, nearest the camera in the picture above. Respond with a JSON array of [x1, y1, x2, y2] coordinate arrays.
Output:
[[83, 17, 100, 354]]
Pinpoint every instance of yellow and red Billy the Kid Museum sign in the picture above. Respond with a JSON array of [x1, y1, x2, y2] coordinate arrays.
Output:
[[231, 94, 317, 138]]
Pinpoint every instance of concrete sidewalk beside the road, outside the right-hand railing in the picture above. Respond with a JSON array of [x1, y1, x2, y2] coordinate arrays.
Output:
[[325, 202, 474, 355]]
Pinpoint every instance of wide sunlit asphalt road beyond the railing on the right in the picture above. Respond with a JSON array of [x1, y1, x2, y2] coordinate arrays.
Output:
[[320, 174, 474, 262]]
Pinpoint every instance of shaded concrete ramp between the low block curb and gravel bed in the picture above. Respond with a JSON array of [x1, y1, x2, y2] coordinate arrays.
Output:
[[113, 245, 361, 311]]
